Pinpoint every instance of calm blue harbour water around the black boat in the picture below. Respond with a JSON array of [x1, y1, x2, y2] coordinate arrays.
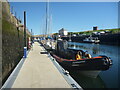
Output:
[[69, 42, 120, 88]]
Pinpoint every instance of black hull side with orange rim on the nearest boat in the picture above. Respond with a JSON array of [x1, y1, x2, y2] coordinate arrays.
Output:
[[53, 55, 111, 71]]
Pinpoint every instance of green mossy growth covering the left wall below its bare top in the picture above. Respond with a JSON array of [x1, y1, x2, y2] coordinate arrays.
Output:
[[2, 12, 29, 82]]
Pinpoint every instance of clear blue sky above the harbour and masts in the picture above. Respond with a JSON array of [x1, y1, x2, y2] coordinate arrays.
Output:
[[10, 2, 118, 35]]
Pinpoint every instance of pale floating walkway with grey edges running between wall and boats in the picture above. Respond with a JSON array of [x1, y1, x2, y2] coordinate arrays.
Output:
[[3, 42, 82, 89]]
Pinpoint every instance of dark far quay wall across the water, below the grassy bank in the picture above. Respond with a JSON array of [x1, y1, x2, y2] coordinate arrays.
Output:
[[62, 33, 120, 45]]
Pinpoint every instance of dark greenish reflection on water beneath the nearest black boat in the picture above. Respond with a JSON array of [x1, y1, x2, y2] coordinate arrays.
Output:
[[70, 71, 106, 88]]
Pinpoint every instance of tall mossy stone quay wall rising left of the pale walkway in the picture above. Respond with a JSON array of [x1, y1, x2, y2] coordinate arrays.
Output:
[[0, 2, 29, 84]]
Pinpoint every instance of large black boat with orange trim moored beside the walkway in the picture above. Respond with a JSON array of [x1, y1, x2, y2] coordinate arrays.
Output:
[[51, 40, 112, 77]]
